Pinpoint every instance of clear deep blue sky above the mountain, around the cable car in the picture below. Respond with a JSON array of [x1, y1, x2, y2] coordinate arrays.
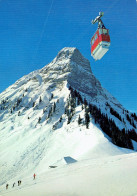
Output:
[[0, 0, 137, 112]]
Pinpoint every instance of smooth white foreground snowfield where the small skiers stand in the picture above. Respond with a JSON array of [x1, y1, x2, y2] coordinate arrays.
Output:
[[0, 153, 137, 196]]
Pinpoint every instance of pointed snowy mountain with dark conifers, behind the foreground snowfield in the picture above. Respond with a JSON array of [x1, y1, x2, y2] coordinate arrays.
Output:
[[0, 48, 137, 195]]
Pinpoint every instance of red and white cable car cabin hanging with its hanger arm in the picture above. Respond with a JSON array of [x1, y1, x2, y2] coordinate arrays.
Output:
[[91, 12, 110, 60]]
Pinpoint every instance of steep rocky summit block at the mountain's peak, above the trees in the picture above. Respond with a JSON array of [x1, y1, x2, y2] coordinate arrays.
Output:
[[42, 48, 105, 98]]
